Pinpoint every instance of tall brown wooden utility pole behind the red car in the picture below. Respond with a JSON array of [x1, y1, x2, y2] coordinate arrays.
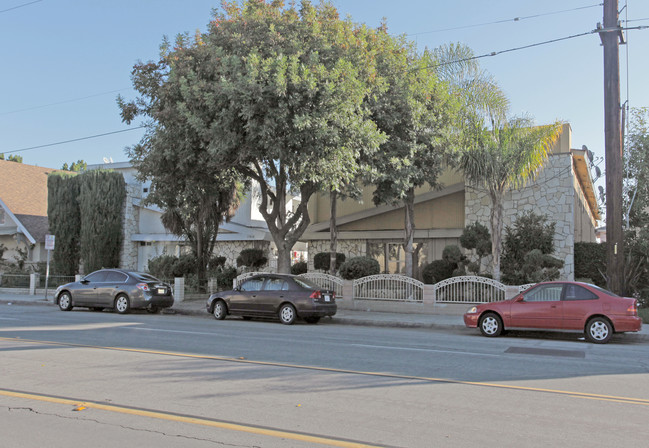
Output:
[[597, 0, 624, 294]]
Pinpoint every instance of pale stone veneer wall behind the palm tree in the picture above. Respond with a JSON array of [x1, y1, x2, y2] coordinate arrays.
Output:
[[465, 153, 575, 280]]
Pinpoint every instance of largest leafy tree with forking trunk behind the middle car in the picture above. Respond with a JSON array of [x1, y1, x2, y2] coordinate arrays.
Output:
[[122, 0, 381, 272]]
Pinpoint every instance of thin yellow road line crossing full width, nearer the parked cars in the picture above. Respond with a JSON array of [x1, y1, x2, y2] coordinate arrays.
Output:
[[0, 337, 649, 406]]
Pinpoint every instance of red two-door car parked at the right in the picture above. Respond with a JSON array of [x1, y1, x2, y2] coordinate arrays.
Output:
[[464, 282, 642, 344]]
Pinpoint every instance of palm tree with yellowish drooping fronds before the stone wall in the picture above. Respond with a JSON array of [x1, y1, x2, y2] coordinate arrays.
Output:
[[458, 117, 561, 280]]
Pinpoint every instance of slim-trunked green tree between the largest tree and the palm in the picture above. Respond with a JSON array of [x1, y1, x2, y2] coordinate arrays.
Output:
[[371, 33, 457, 277]]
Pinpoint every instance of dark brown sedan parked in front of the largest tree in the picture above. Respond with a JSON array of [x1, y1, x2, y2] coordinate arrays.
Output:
[[207, 274, 337, 325]]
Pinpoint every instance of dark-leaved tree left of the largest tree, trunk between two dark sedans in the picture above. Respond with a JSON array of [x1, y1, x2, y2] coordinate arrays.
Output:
[[118, 37, 246, 286]]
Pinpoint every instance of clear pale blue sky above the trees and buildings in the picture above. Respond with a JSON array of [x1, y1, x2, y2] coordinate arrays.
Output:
[[0, 0, 649, 182]]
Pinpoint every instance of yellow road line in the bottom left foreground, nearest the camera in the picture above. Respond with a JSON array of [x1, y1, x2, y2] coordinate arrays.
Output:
[[0, 389, 380, 448]]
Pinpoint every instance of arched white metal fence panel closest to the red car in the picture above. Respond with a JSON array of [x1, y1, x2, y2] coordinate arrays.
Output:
[[433, 276, 506, 303]]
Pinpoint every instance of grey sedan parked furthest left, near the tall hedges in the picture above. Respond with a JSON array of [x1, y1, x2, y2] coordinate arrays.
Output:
[[54, 269, 174, 314]]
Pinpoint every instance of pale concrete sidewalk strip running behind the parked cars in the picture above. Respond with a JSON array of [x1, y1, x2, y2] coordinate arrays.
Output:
[[0, 291, 649, 341]]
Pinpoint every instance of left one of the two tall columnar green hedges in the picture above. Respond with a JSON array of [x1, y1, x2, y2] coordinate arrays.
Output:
[[47, 173, 81, 275]]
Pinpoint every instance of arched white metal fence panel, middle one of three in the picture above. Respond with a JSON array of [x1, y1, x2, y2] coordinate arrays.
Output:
[[354, 274, 424, 302]]
